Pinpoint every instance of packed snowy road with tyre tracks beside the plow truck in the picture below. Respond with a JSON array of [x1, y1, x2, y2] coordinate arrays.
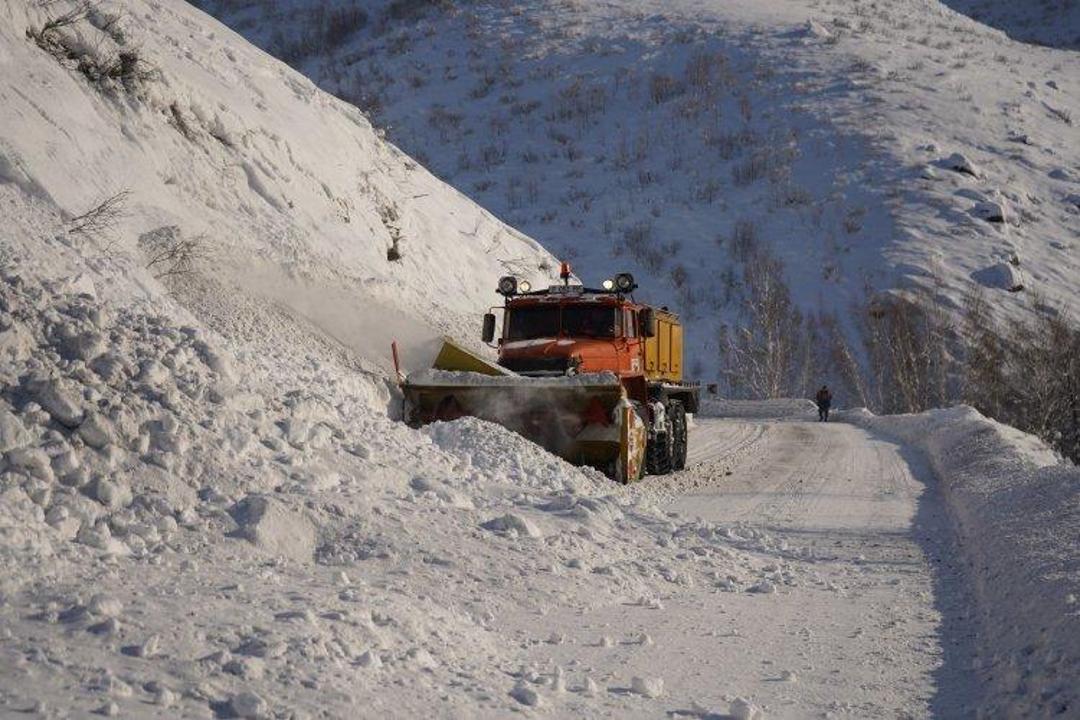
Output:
[[514, 419, 980, 718]]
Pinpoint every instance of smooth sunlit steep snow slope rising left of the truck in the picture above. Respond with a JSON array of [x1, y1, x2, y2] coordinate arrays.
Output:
[[0, 2, 551, 367]]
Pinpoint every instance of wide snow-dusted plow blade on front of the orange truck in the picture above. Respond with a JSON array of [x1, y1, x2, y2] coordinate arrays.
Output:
[[402, 368, 646, 483]]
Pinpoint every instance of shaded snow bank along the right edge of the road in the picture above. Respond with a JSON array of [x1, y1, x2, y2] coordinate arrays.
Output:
[[840, 406, 1080, 718]]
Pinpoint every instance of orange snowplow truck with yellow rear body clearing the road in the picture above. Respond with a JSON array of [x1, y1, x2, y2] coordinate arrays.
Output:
[[402, 263, 699, 483]]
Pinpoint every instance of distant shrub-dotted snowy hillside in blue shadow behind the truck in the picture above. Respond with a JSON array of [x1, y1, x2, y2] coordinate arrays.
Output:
[[201, 0, 1080, 386]]
